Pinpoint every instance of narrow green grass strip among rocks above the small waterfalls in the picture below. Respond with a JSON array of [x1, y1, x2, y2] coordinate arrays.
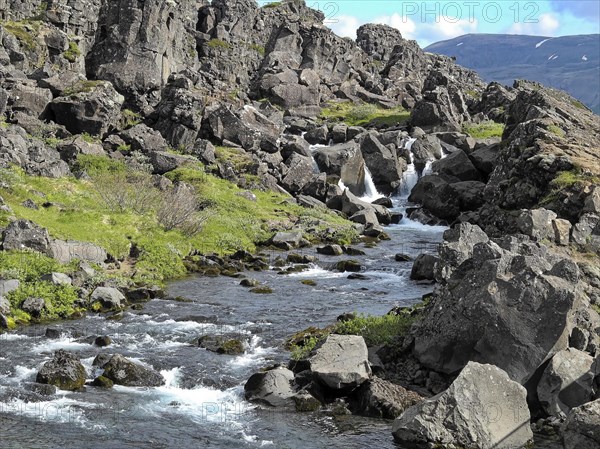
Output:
[[319, 101, 410, 126]]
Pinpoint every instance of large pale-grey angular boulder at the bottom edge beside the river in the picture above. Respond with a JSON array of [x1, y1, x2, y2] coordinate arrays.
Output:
[[392, 362, 533, 449]]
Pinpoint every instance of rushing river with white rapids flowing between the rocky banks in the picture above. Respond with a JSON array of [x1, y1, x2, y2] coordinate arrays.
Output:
[[0, 144, 444, 449]]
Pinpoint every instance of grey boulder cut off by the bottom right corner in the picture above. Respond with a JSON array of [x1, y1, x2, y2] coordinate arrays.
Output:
[[561, 399, 600, 449]]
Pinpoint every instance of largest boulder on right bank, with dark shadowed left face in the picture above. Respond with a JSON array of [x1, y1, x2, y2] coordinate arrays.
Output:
[[411, 231, 600, 388]]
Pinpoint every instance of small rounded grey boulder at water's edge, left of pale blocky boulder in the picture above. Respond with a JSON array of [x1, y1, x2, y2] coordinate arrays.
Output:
[[244, 367, 295, 407]]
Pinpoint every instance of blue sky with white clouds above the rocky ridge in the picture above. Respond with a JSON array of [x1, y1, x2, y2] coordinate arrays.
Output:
[[270, 0, 600, 47]]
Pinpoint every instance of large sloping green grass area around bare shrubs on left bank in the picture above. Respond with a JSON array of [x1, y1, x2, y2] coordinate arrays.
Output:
[[0, 163, 356, 283]]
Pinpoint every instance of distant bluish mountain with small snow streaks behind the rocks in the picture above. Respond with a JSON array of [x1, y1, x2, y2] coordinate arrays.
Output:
[[425, 34, 600, 114]]
